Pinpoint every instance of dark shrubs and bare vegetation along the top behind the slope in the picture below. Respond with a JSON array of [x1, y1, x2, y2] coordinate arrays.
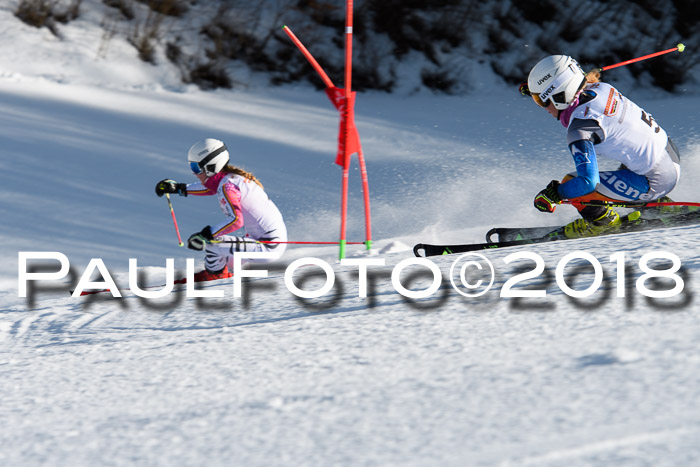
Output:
[[15, 0, 700, 93]]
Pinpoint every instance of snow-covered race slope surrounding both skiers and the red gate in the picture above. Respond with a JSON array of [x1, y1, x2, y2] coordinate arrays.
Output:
[[0, 4, 700, 466]]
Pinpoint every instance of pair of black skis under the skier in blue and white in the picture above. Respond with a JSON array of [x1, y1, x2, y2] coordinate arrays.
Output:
[[413, 211, 700, 257]]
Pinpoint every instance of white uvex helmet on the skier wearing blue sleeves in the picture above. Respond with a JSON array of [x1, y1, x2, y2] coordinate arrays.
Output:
[[527, 55, 586, 110]]
